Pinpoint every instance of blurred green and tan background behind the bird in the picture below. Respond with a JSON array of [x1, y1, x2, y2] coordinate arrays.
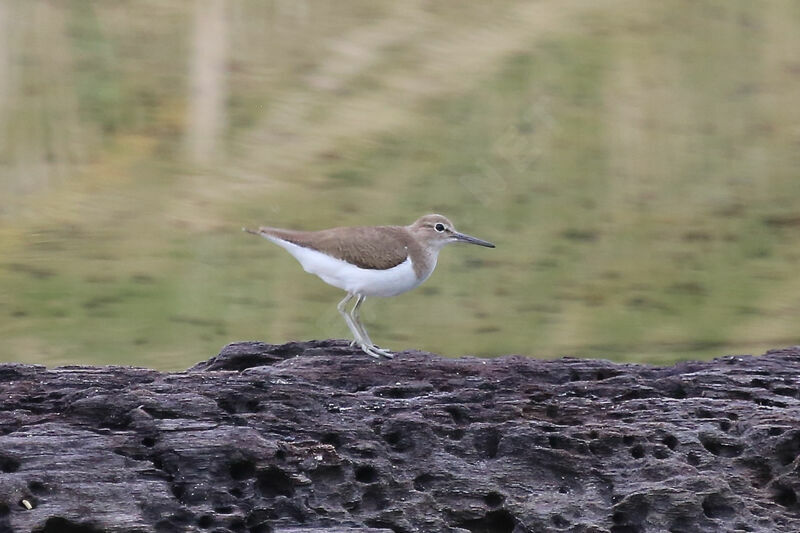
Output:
[[0, 0, 800, 369]]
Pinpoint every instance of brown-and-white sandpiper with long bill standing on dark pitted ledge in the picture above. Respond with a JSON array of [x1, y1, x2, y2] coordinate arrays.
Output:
[[242, 214, 495, 359]]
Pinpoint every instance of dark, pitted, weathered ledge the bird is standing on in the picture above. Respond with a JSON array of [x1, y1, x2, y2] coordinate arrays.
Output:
[[0, 341, 800, 533]]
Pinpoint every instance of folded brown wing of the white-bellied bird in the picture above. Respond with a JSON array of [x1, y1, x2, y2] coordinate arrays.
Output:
[[261, 226, 410, 270]]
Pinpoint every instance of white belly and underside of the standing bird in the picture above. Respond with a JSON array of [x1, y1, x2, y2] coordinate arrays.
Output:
[[265, 236, 433, 296]]
